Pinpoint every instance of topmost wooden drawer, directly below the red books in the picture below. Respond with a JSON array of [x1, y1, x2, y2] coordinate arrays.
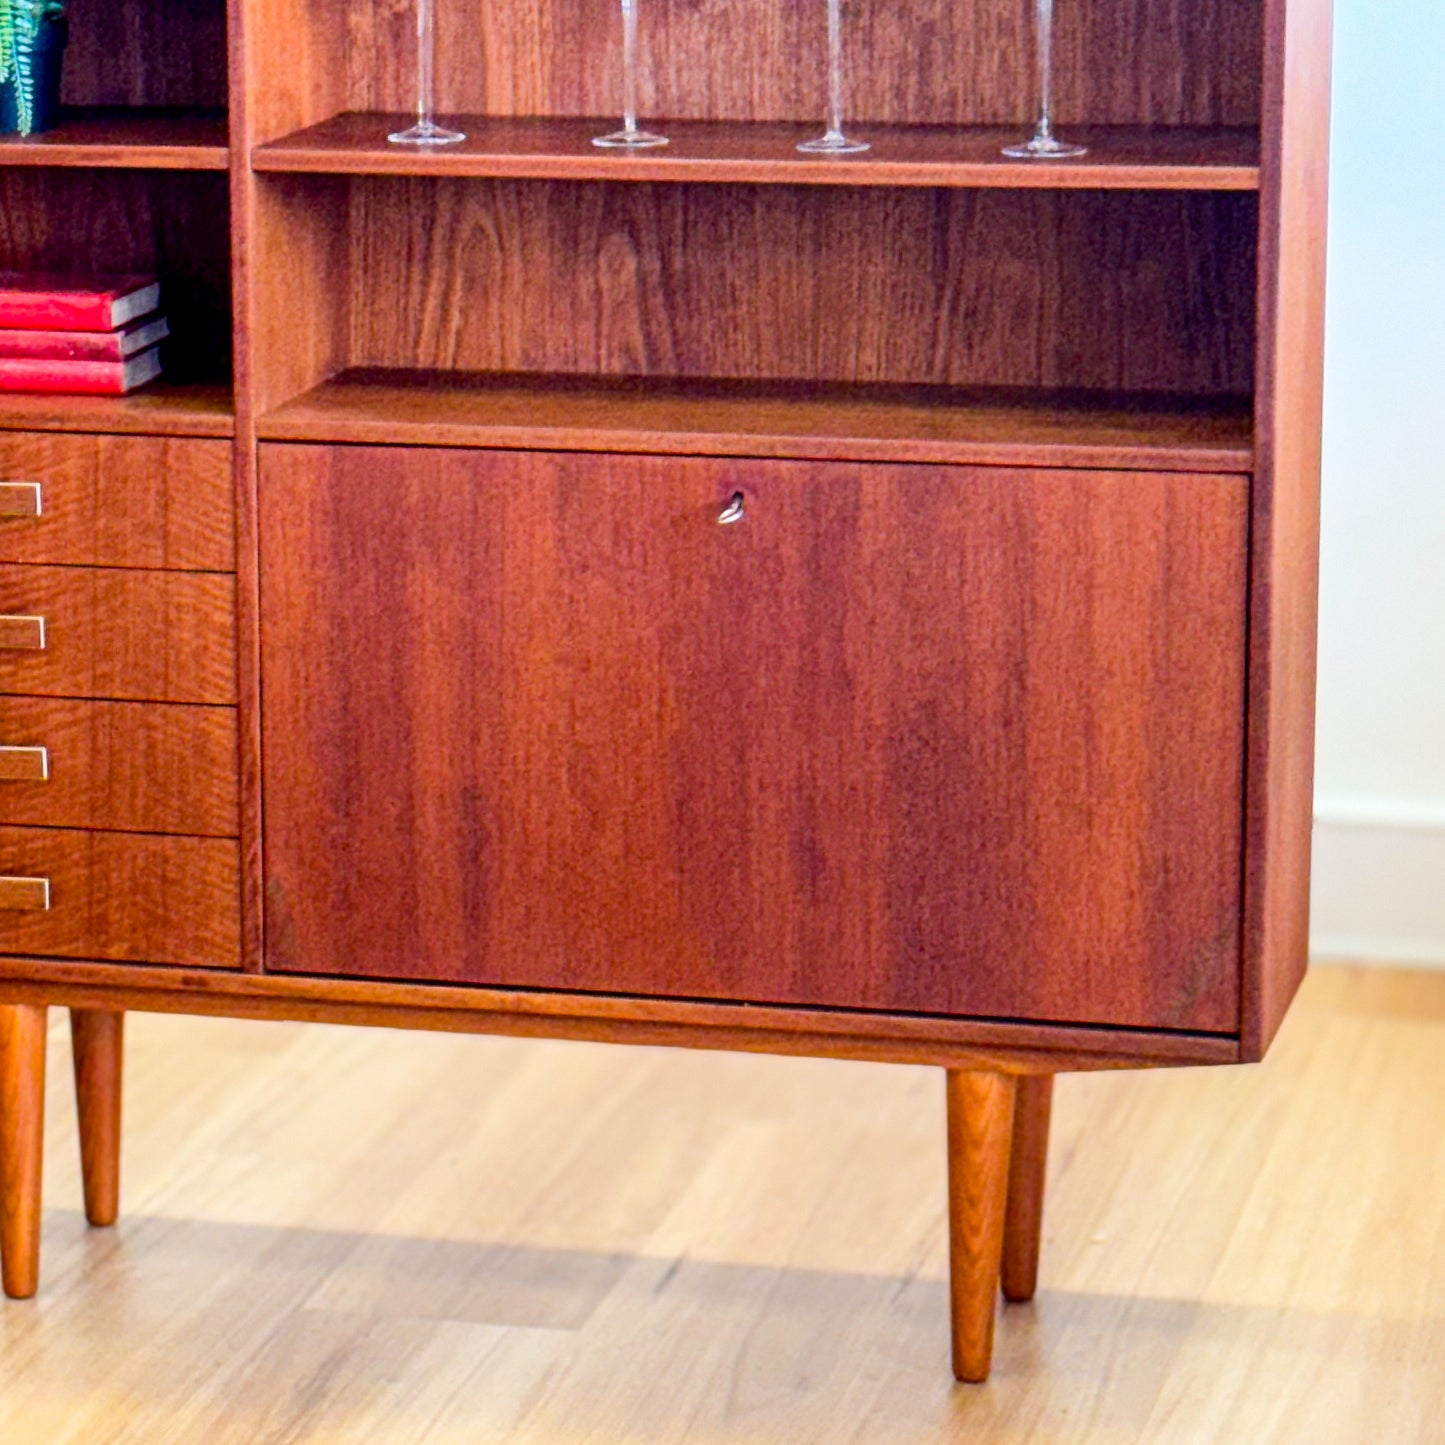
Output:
[[0, 432, 236, 572]]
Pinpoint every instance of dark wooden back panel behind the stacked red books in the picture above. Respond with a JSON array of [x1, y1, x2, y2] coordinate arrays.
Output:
[[0, 166, 231, 387]]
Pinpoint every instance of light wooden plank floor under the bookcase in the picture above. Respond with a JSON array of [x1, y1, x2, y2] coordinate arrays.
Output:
[[0, 968, 1445, 1445]]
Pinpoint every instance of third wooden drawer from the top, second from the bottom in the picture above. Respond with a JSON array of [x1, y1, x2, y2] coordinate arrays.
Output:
[[0, 696, 237, 837]]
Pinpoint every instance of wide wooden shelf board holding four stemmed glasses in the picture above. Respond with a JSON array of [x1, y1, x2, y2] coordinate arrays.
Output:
[[251, 111, 1259, 191]]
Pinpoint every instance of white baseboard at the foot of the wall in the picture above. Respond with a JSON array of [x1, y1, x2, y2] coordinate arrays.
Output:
[[1309, 798, 1445, 967]]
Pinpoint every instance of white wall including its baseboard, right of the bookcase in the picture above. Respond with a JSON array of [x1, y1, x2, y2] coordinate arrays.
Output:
[[1312, 0, 1445, 962]]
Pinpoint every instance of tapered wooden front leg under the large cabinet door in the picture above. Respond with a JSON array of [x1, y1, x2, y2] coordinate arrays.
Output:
[[948, 1069, 1014, 1383]]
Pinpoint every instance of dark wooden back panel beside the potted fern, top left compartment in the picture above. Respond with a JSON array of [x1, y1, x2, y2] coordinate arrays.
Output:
[[61, 0, 227, 111]]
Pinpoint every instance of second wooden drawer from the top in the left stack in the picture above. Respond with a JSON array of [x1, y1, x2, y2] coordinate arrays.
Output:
[[0, 564, 236, 704]]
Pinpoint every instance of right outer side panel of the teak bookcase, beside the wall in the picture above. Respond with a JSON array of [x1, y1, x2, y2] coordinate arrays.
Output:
[[1244, 0, 1331, 1058]]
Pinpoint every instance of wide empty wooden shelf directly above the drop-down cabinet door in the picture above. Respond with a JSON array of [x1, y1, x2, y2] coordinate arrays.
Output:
[[257, 368, 1254, 473]]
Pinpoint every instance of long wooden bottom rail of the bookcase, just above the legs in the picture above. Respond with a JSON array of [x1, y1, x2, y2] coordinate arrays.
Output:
[[0, 955, 1238, 1075]]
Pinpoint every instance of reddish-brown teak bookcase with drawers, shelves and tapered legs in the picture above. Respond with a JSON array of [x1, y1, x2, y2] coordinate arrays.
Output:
[[0, 0, 1329, 1380]]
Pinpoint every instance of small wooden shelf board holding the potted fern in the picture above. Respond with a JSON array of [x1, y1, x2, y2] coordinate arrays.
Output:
[[0, 107, 230, 171]]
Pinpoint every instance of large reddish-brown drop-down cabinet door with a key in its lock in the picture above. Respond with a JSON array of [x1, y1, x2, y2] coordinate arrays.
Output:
[[260, 444, 1248, 1032]]
